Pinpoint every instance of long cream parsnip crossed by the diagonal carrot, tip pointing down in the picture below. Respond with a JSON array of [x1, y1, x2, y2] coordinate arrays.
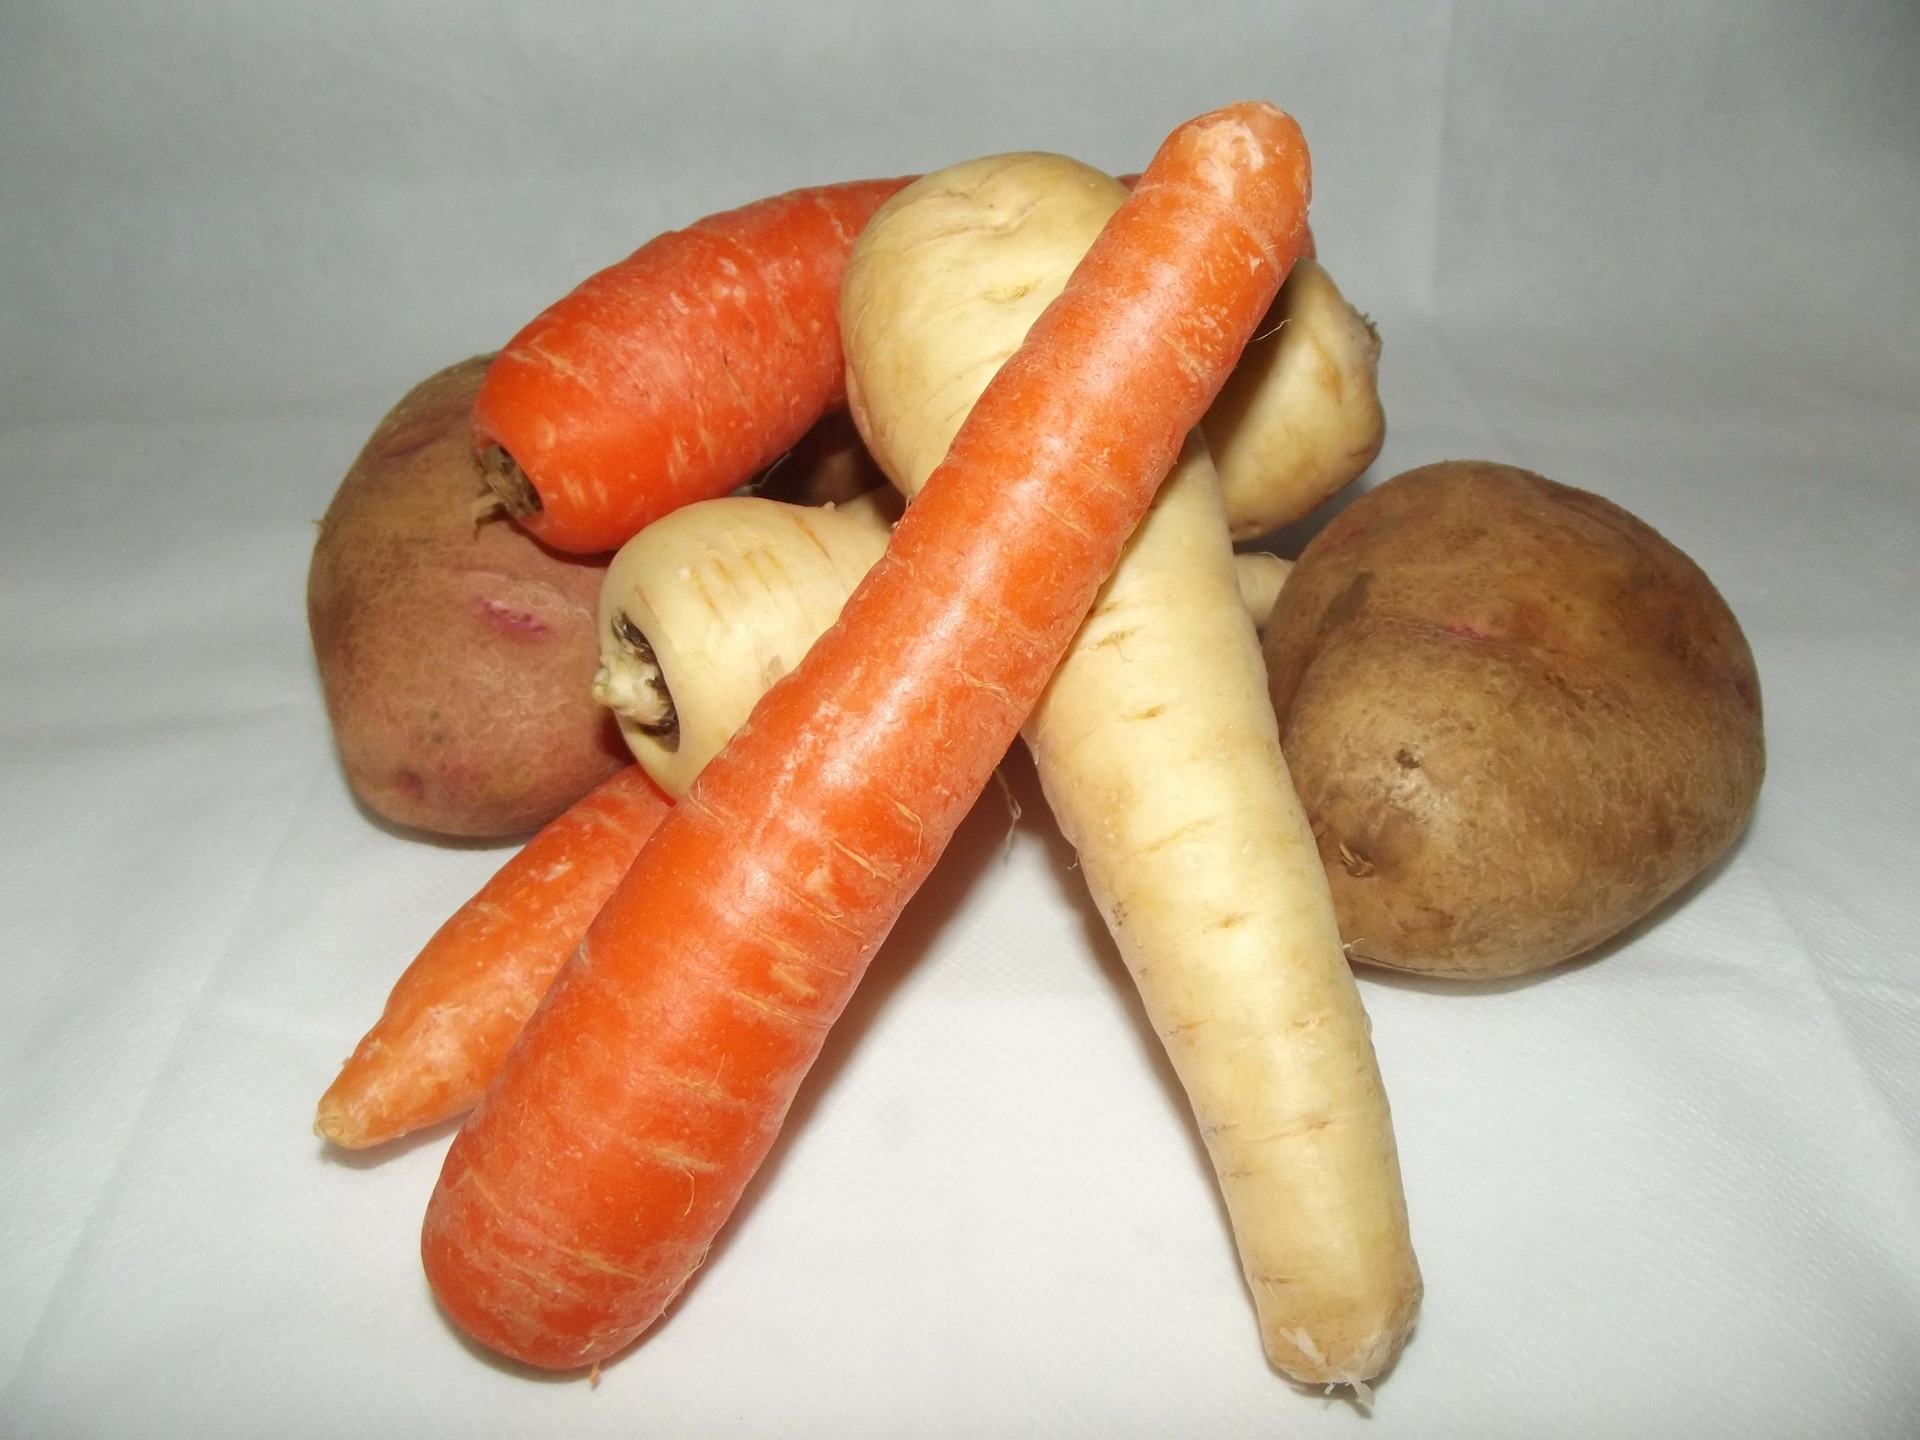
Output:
[[841, 154, 1421, 1390]]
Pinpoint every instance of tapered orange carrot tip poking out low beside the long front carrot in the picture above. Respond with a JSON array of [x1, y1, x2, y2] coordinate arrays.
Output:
[[313, 764, 672, 1150]]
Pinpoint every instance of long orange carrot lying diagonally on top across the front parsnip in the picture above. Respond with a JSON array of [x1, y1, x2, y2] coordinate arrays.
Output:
[[420, 104, 1308, 1369]]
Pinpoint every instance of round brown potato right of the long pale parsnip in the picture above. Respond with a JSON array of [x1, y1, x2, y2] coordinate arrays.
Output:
[[1265, 461, 1764, 977]]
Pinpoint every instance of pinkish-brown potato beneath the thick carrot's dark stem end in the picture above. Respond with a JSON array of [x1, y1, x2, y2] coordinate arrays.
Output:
[[307, 355, 628, 837]]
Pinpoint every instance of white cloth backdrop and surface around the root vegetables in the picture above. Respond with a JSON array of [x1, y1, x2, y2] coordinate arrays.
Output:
[[0, 0, 1920, 1436]]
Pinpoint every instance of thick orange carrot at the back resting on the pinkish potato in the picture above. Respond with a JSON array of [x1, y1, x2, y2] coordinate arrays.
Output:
[[474, 180, 904, 553]]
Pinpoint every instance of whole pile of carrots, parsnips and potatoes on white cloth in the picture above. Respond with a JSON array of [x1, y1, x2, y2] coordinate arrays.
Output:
[[309, 104, 1761, 1404]]
